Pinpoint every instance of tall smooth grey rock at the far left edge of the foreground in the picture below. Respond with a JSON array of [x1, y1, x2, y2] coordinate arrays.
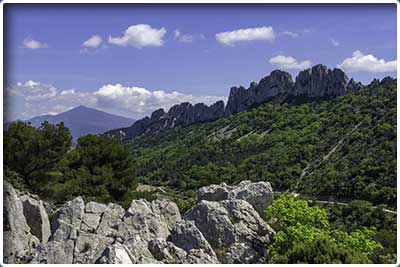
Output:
[[3, 181, 39, 263]]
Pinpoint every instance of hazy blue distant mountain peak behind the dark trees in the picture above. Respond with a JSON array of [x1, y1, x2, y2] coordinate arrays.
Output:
[[27, 106, 135, 142]]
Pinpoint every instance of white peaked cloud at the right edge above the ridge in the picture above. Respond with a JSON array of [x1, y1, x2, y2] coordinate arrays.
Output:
[[337, 50, 397, 72]]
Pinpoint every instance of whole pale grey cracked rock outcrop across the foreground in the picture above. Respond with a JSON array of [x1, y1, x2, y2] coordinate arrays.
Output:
[[3, 181, 275, 264]]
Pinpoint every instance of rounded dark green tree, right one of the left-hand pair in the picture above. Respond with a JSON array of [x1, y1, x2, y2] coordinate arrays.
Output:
[[51, 135, 136, 204]]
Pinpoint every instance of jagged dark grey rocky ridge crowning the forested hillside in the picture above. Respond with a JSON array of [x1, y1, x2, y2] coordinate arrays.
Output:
[[105, 65, 362, 141]]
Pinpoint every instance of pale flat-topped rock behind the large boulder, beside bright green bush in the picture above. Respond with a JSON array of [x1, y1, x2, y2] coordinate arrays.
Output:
[[196, 181, 273, 215]]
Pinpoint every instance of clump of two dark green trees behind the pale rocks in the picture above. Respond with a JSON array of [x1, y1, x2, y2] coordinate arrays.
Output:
[[4, 126, 136, 206]]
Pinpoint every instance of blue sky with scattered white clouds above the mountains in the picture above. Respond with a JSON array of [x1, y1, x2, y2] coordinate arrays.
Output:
[[4, 4, 397, 120]]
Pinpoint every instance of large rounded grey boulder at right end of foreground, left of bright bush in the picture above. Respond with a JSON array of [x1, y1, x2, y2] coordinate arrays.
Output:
[[184, 200, 275, 263]]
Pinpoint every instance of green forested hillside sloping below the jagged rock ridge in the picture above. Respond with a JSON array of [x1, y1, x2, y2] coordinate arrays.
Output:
[[127, 79, 396, 207]]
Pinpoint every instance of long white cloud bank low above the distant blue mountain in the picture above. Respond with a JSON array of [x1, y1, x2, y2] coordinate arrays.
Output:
[[6, 81, 227, 120]]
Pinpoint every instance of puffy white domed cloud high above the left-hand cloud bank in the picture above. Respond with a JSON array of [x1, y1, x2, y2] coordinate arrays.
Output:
[[108, 24, 167, 48]]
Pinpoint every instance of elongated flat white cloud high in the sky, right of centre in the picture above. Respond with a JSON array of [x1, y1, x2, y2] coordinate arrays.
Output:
[[215, 27, 275, 46]]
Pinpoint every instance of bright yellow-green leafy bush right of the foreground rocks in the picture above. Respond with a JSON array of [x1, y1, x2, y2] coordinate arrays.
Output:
[[266, 194, 382, 264]]
